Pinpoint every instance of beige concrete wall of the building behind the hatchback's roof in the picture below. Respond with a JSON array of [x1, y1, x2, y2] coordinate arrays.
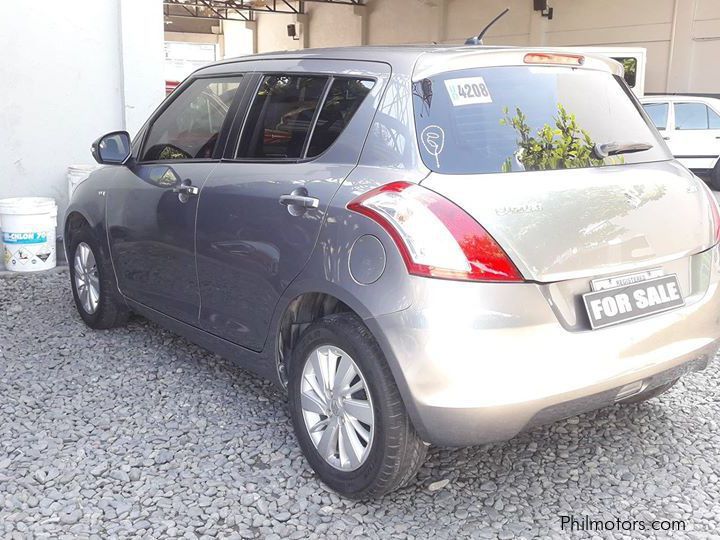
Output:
[[252, 0, 720, 93]]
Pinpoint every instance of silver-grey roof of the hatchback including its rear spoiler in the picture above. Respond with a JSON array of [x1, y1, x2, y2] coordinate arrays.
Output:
[[198, 44, 622, 76]]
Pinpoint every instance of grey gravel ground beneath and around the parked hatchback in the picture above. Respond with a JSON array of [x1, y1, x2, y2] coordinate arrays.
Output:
[[0, 271, 720, 538]]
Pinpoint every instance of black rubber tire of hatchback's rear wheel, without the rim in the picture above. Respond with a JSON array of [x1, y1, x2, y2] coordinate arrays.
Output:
[[288, 313, 427, 499]]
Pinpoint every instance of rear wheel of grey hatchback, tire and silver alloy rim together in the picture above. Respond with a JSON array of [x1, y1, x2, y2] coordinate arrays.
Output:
[[288, 313, 426, 499]]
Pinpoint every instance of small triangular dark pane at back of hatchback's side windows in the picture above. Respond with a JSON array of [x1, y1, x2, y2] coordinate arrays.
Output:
[[307, 78, 374, 157]]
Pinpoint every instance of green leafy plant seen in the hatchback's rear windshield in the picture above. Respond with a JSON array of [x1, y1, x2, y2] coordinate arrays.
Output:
[[500, 104, 604, 172]]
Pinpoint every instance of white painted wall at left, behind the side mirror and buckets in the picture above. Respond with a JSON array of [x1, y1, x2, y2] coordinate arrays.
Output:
[[0, 0, 164, 230]]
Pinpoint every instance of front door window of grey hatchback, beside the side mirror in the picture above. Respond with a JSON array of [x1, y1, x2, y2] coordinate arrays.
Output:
[[141, 77, 240, 161]]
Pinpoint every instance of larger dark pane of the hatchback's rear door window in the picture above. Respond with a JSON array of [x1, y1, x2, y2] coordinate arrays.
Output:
[[236, 75, 328, 159]]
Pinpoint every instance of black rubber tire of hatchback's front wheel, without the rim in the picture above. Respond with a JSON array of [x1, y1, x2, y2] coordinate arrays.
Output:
[[68, 225, 130, 330]]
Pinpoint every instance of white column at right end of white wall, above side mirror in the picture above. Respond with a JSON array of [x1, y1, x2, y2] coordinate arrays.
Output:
[[119, 0, 165, 136]]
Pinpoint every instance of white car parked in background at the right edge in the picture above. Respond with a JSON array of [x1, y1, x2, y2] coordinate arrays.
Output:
[[640, 96, 720, 190]]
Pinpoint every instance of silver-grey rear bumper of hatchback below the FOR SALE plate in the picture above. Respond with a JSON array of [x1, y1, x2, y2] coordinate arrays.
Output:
[[366, 248, 720, 446]]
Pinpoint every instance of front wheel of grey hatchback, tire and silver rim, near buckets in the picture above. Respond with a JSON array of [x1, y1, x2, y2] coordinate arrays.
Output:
[[68, 226, 130, 329]]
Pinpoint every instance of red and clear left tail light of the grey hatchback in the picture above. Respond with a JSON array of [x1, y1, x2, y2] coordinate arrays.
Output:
[[348, 182, 523, 281]]
